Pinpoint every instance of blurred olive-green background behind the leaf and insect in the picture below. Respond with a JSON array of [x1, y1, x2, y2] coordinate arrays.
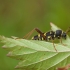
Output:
[[0, 0, 70, 70]]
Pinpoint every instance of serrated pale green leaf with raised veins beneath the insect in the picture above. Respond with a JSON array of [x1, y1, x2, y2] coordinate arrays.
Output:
[[0, 24, 70, 70]]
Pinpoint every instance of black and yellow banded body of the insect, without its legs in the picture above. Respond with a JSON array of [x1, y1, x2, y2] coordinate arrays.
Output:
[[32, 30, 66, 41]]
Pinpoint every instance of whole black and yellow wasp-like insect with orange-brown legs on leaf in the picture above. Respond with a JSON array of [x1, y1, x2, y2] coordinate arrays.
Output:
[[23, 27, 70, 51]]
